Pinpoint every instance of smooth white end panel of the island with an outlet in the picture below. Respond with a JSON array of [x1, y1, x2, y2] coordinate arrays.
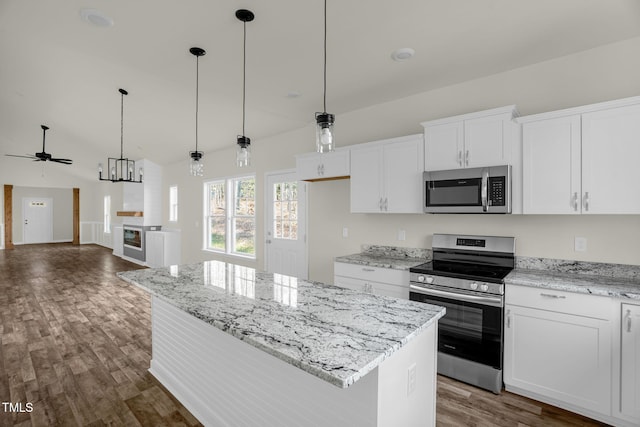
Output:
[[378, 322, 438, 427]]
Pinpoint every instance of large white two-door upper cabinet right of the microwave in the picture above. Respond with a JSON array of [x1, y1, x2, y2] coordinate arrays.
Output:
[[519, 97, 640, 214]]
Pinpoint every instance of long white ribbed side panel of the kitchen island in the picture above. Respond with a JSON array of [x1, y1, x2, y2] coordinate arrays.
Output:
[[149, 296, 380, 427]]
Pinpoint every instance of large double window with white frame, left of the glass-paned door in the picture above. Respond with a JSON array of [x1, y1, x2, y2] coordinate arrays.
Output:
[[204, 176, 256, 257]]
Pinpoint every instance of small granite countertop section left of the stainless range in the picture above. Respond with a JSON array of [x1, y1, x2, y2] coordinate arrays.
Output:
[[334, 245, 431, 270]]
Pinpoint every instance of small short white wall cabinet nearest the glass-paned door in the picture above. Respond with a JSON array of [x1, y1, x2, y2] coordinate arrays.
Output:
[[296, 148, 350, 181]]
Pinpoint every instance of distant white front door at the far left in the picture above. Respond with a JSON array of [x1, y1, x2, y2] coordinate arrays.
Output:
[[22, 197, 53, 244]]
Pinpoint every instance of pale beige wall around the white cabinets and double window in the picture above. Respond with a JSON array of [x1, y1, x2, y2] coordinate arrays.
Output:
[[163, 38, 640, 282]]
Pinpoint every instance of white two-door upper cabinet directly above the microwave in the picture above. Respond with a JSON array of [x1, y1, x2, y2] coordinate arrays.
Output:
[[422, 105, 518, 171]]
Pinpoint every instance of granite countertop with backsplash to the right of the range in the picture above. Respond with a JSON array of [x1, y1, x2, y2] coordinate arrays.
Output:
[[505, 257, 640, 301]]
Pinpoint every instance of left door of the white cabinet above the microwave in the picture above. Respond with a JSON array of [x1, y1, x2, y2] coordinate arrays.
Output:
[[424, 121, 464, 171]]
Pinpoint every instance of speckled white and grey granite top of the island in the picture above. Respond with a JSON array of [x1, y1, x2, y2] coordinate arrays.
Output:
[[118, 261, 444, 388]]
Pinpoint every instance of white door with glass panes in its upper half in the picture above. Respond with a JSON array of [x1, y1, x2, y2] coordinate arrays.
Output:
[[265, 171, 309, 279]]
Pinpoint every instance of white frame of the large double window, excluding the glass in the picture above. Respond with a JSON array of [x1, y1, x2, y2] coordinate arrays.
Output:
[[202, 174, 257, 259]]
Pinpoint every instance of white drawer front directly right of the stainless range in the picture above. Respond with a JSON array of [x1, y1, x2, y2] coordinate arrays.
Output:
[[505, 285, 612, 320]]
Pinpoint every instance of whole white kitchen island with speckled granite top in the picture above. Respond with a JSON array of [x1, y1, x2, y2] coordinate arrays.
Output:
[[118, 261, 445, 426]]
